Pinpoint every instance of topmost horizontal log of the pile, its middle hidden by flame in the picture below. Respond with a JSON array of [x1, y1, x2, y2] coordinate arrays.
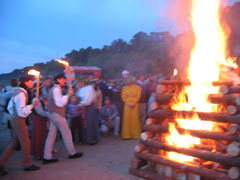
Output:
[[159, 80, 233, 87]]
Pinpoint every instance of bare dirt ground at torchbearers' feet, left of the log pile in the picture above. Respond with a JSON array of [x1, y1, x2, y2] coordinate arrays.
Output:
[[0, 130, 139, 180]]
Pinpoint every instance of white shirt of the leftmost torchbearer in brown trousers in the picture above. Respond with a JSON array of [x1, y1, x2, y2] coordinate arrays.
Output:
[[7, 88, 32, 118]]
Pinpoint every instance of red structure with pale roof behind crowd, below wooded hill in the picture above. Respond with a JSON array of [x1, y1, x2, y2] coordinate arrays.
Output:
[[69, 66, 102, 80]]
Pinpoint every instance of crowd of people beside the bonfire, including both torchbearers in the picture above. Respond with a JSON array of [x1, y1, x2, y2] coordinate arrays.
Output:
[[0, 70, 163, 175]]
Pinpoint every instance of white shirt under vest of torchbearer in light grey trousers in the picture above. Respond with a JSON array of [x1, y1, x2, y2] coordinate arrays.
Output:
[[53, 84, 68, 107]]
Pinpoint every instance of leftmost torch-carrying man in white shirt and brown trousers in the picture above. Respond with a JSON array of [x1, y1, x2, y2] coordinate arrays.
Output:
[[0, 75, 40, 175]]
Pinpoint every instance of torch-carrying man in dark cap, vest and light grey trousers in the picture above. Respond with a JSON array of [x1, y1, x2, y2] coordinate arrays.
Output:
[[43, 73, 83, 164]]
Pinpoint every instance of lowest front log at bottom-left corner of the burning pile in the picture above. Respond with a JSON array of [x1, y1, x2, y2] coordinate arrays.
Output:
[[129, 168, 173, 180]]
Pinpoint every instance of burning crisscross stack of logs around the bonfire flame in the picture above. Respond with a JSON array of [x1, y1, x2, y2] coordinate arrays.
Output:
[[129, 80, 240, 180]]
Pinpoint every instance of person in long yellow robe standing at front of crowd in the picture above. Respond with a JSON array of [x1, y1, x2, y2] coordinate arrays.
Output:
[[121, 77, 142, 139]]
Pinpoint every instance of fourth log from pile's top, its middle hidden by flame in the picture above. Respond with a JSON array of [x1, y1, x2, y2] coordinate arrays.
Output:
[[143, 124, 240, 142]]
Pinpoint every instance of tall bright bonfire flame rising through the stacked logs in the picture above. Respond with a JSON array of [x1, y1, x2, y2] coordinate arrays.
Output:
[[165, 0, 232, 161]]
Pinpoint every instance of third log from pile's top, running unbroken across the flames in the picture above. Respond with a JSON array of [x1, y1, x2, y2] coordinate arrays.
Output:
[[148, 109, 240, 124]]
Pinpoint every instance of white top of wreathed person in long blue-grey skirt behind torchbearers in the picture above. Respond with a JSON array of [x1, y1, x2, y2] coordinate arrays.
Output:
[[76, 85, 96, 106]]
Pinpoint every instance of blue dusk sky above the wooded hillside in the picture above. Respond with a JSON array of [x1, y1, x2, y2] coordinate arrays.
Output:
[[0, 0, 238, 74]]
